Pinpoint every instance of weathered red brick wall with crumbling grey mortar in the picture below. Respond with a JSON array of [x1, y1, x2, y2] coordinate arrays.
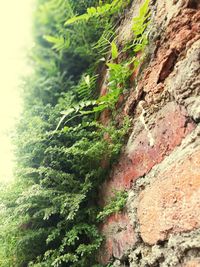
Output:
[[99, 0, 200, 267]]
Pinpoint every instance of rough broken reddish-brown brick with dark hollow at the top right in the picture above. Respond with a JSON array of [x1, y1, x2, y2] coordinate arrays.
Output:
[[139, 9, 200, 102]]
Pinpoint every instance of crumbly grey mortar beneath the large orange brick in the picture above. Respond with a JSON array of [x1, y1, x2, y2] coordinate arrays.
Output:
[[127, 229, 200, 267]]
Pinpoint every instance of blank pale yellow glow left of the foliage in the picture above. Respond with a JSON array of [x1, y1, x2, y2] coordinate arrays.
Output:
[[0, 0, 32, 181]]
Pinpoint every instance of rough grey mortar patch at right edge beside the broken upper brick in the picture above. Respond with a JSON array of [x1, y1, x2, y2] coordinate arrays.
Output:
[[166, 40, 200, 121]]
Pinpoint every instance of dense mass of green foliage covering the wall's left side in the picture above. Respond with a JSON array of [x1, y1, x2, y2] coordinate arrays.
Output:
[[0, 0, 149, 267]]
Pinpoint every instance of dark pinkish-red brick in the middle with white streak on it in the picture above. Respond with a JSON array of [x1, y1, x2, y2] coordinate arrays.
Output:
[[101, 102, 194, 202]]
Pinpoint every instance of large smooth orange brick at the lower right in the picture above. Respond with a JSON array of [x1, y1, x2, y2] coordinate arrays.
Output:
[[137, 151, 200, 244]]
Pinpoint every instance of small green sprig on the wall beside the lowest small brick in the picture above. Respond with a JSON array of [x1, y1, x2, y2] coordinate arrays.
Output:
[[97, 191, 128, 221]]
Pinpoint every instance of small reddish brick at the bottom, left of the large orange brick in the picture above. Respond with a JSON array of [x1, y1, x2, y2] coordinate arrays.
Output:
[[98, 213, 136, 264]]
